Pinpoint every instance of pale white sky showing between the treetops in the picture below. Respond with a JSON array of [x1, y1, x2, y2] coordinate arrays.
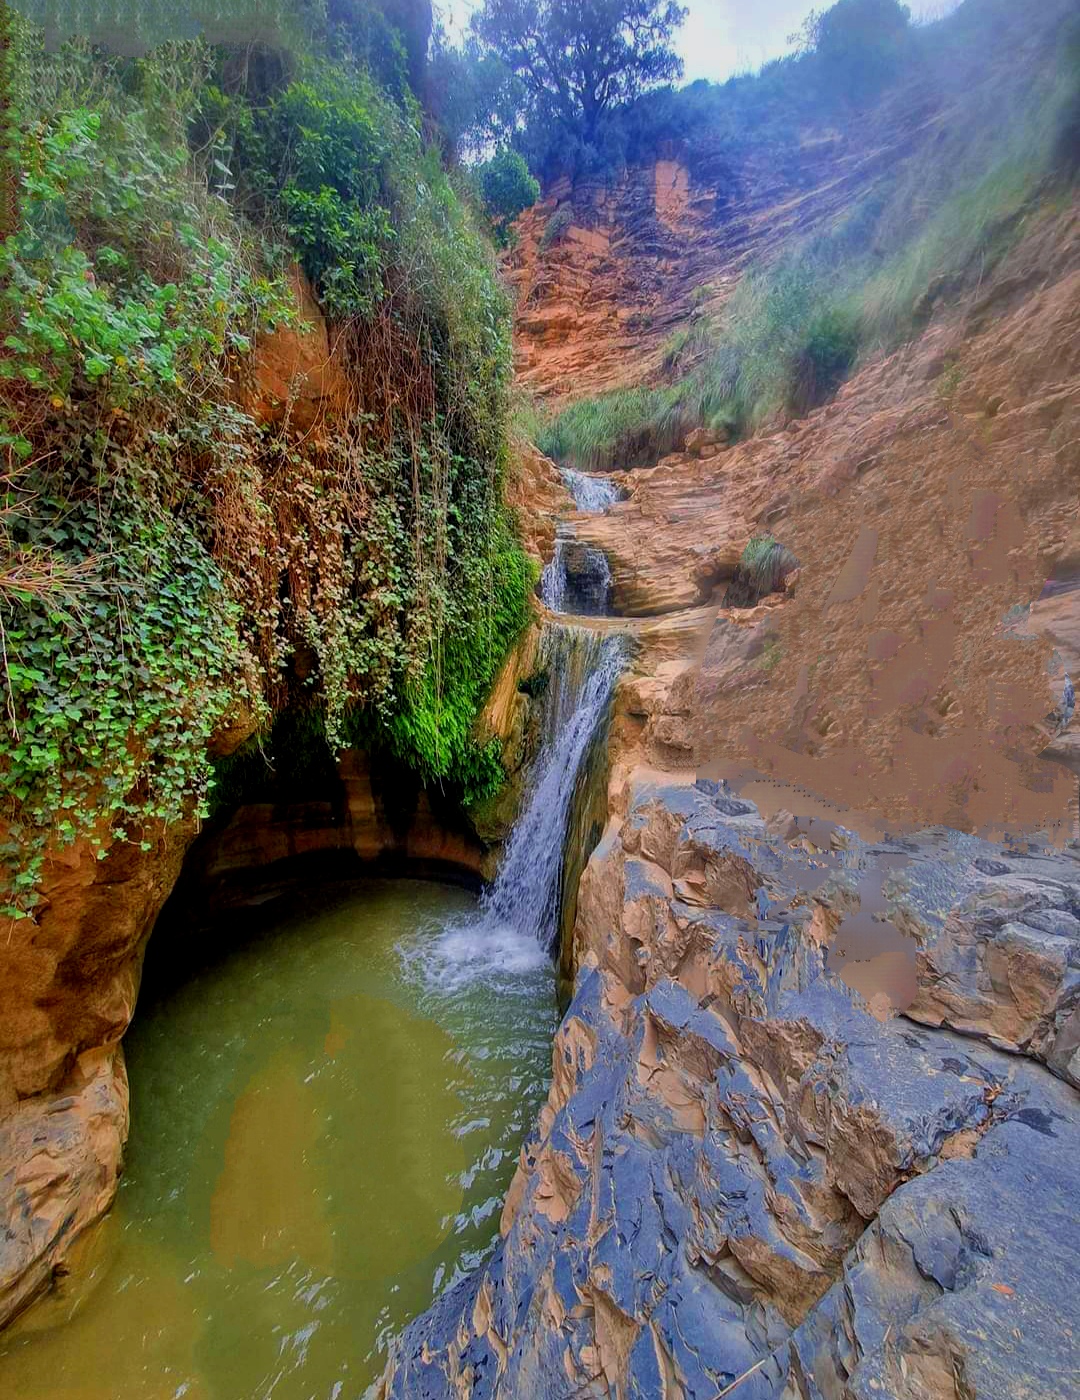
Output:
[[437, 0, 955, 81]]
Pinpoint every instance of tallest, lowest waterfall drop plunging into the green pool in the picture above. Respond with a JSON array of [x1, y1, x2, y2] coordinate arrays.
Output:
[[482, 627, 626, 952]]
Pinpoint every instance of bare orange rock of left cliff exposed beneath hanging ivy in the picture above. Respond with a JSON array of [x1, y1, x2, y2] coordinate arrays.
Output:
[[0, 284, 549, 1326]]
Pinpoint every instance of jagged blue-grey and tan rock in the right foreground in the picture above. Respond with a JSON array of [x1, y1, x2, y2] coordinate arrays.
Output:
[[380, 777, 1080, 1400]]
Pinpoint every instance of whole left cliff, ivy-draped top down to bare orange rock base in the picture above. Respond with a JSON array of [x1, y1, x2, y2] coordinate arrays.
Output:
[[0, 0, 535, 1322]]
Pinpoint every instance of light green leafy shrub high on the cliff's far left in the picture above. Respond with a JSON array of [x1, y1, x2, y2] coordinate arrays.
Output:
[[0, 90, 286, 407]]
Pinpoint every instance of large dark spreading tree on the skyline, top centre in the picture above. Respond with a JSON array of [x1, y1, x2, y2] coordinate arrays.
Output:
[[472, 0, 686, 143]]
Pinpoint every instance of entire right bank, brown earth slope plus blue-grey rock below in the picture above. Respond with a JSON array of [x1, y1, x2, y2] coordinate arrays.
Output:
[[377, 133, 1080, 1400]]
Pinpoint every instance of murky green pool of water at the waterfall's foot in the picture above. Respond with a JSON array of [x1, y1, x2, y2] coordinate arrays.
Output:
[[0, 881, 555, 1400]]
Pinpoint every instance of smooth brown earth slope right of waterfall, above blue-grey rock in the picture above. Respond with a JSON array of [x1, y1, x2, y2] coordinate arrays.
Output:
[[591, 210, 1080, 832]]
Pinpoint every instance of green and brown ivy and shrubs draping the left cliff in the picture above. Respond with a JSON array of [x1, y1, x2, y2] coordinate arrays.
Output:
[[0, 6, 531, 913]]
